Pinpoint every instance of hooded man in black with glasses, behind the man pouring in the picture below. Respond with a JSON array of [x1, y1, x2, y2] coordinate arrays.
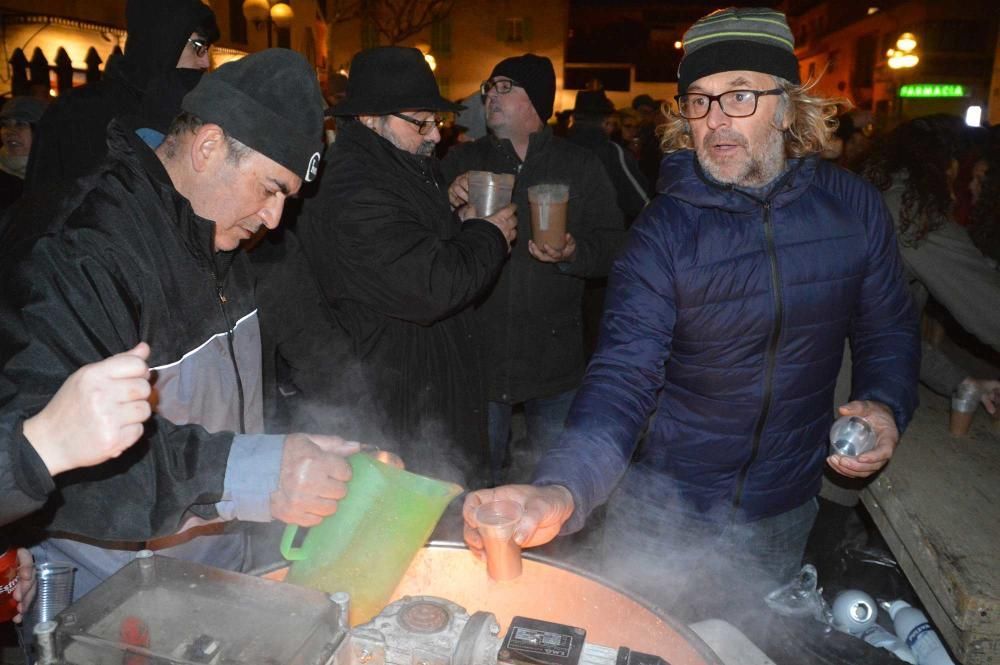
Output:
[[25, 0, 219, 193]]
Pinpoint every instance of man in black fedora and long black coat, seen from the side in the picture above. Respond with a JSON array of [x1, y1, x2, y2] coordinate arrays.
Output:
[[297, 47, 517, 486]]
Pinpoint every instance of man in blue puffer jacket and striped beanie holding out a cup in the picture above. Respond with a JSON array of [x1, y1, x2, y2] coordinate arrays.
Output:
[[465, 9, 919, 620]]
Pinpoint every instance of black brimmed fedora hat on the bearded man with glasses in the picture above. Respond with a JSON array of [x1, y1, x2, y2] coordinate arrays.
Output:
[[327, 46, 465, 115]]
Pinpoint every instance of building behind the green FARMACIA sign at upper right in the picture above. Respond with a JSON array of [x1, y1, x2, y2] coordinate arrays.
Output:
[[790, 0, 998, 128]]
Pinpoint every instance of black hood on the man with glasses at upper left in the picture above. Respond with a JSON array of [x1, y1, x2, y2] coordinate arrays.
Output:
[[120, 0, 218, 85]]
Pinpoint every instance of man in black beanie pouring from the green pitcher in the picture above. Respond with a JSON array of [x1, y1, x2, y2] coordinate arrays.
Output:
[[0, 49, 358, 597]]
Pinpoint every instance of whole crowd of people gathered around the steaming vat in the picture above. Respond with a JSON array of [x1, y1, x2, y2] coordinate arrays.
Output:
[[0, 0, 1000, 648]]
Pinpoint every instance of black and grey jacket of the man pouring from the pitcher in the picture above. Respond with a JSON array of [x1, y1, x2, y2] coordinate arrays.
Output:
[[0, 123, 262, 541]]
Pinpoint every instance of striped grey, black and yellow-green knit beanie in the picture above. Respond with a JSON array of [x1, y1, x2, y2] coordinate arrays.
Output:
[[677, 7, 799, 95]]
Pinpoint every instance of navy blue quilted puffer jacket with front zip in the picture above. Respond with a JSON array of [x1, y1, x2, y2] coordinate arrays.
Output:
[[534, 151, 920, 532]]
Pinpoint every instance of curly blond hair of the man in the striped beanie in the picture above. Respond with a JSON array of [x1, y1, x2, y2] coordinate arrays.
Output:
[[656, 76, 853, 157]]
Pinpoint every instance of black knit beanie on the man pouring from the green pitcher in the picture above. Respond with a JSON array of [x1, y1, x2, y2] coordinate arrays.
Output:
[[181, 48, 323, 182]]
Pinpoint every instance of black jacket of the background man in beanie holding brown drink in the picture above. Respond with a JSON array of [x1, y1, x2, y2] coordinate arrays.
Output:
[[442, 129, 624, 404]]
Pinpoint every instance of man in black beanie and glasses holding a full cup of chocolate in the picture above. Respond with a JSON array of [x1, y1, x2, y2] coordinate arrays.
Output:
[[442, 53, 624, 483]]
